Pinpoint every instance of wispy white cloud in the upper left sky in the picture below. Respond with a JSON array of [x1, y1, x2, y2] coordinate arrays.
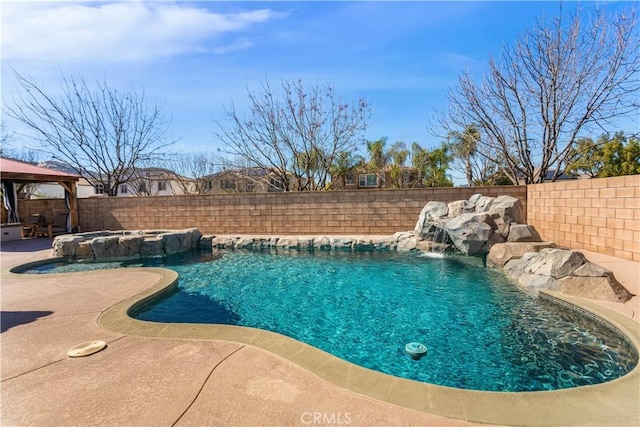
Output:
[[2, 1, 279, 63]]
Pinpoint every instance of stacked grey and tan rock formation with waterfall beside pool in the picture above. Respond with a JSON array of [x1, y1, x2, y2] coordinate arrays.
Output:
[[410, 194, 633, 302]]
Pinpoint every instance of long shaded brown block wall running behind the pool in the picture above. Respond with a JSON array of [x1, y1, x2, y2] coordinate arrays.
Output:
[[20, 186, 527, 235]]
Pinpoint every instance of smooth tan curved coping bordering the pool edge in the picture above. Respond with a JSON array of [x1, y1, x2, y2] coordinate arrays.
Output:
[[4, 254, 640, 425]]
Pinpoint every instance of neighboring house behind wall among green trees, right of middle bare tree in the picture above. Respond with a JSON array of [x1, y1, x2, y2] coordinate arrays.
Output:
[[331, 166, 420, 190]]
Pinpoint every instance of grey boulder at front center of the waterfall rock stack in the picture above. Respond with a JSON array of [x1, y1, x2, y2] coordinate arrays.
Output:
[[445, 213, 494, 255]]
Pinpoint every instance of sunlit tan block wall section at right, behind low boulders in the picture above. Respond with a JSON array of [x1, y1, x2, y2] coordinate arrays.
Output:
[[527, 175, 640, 262]]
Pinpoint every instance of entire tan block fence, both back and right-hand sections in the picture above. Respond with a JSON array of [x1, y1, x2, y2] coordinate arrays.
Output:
[[19, 175, 640, 262]]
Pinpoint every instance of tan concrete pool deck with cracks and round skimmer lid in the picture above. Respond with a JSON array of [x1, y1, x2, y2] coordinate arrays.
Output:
[[0, 239, 640, 426]]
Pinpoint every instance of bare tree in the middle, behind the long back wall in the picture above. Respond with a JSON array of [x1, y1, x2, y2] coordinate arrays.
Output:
[[217, 80, 370, 191]]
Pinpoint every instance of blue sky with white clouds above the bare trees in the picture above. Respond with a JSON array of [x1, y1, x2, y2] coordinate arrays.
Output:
[[1, 1, 637, 165]]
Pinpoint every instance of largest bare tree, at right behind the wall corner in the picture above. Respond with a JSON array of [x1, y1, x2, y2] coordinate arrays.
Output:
[[439, 6, 640, 184]]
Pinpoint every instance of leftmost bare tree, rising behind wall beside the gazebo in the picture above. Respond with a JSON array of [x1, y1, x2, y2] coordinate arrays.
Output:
[[5, 73, 172, 196]]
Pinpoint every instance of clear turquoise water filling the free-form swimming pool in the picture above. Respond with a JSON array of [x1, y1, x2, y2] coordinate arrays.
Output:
[[22, 251, 638, 391]]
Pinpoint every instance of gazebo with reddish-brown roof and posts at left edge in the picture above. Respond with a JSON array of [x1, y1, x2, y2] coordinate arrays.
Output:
[[0, 157, 81, 232]]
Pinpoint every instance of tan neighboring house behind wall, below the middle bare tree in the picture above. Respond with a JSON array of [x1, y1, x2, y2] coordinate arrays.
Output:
[[198, 167, 294, 194]]
